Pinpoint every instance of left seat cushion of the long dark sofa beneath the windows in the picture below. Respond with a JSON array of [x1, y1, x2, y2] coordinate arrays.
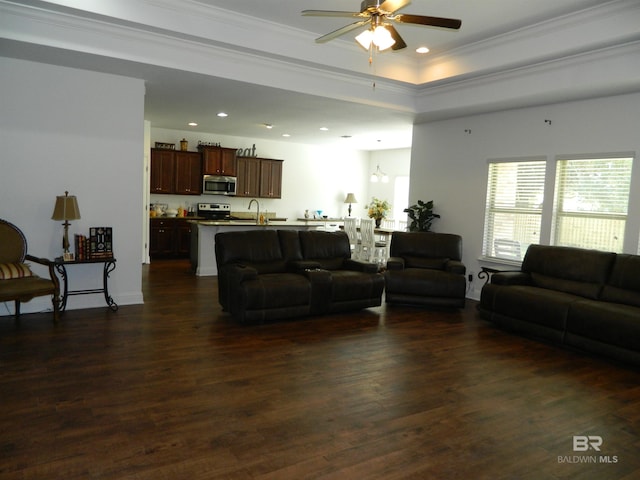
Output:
[[482, 284, 581, 330]]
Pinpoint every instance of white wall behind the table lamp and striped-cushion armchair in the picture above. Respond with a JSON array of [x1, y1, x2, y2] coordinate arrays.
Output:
[[0, 58, 144, 315]]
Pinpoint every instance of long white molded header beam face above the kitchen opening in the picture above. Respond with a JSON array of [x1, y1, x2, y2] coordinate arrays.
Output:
[[0, 2, 415, 112]]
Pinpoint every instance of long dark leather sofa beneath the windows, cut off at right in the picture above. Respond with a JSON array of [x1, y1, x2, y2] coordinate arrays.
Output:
[[478, 245, 640, 365]]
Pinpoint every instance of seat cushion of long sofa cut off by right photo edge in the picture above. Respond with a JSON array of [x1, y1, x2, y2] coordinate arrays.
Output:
[[567, 300, 640, 351]]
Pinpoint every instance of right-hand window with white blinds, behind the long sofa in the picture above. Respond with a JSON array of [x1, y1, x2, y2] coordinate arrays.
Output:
[[552, 156, 633, 252]]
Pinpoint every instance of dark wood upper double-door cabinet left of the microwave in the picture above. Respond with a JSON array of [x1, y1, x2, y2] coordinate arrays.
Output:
[[149, 148, 202, 195]]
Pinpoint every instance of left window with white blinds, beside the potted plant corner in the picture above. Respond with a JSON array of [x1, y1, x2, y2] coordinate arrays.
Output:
[[482, 158, 546, 262]]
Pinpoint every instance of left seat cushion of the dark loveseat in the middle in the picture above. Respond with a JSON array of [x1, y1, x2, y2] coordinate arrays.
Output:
[[240, 273, 311, 310]]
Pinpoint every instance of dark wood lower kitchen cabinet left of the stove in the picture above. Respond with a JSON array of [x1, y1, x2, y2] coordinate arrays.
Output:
[[149, 217, 191, 258]]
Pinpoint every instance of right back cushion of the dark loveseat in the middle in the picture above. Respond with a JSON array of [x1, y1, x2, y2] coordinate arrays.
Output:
[[298, 230, 351, 270]]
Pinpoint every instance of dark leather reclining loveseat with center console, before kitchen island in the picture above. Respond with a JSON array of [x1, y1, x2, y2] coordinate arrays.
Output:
[[215, 229, 384, 323]]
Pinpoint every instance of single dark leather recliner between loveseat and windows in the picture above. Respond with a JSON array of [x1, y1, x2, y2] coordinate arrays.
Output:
[[385, 232, 467, 308]]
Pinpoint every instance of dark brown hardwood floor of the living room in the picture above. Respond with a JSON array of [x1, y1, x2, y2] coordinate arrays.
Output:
[[0, 261, 640, 480]]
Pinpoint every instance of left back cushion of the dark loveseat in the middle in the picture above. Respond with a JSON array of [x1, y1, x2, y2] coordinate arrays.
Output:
[[216, 228, 286, 274]]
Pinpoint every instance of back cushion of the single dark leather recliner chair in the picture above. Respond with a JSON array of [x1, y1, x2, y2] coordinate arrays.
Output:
[[390, 232, 462, 264]]
